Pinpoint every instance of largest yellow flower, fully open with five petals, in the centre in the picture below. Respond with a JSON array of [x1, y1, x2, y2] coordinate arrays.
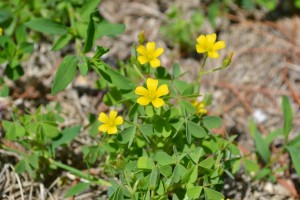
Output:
[[134, 78, 169, 108]]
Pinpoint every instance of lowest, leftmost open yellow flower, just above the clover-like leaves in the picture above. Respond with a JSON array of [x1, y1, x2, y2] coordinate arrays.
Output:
[[98, 110, 123, 134]]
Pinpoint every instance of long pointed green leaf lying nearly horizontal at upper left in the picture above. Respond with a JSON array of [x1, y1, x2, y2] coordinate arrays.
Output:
[[25, 18, 68, 34]]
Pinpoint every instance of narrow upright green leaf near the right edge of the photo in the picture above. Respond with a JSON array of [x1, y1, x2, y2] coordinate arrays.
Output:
[[282, 96, 293, 141]]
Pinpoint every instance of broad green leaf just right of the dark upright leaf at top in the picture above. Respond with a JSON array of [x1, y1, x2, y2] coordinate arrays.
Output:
[[95, 20, 125, 38]]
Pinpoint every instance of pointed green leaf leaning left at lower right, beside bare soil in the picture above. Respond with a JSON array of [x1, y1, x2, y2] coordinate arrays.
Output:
[[254, 131, 271, 163]]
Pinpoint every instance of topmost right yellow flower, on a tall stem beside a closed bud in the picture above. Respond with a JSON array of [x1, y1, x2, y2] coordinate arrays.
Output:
[[196, 34, 225, 58]]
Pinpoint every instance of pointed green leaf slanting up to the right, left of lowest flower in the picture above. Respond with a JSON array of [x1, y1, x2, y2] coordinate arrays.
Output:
[[51, 126, 81, 150]]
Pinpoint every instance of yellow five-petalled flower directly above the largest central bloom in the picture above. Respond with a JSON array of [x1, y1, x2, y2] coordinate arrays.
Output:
[[136, 42, 164, 68]]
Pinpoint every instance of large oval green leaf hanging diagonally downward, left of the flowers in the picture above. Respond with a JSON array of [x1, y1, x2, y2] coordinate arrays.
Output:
[[51, 55, 78, 95]]
